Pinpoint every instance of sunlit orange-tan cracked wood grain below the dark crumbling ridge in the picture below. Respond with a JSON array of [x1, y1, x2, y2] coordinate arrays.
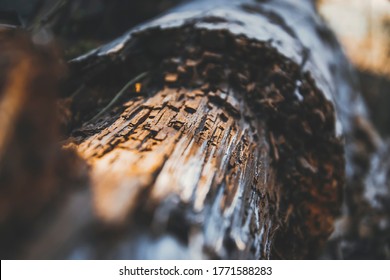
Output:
[[78, 85, 278, 257]]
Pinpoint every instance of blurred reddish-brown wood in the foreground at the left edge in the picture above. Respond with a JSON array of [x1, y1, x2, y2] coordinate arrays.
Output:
[[0, 27, 86, 257]]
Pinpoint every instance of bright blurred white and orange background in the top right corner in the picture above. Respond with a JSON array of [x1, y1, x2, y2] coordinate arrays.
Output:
[[317, 0, 390, 136]]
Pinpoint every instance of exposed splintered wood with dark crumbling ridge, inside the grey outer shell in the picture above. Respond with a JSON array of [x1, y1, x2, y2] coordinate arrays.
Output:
[[65, 19, 344, 259]]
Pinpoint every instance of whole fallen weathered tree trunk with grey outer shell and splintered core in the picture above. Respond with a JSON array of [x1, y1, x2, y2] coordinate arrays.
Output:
[[0, 0, 384, 259]]
